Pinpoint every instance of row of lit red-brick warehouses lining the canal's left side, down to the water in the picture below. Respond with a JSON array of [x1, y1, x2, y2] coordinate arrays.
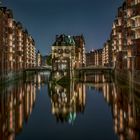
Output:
[[0, 7, 36, 80]]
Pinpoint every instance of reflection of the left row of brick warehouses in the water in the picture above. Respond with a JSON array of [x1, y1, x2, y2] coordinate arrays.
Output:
[[0, 83, 36, 140]]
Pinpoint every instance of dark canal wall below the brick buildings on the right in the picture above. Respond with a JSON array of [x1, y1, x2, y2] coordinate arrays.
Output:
[[113, 70, 140, 91]]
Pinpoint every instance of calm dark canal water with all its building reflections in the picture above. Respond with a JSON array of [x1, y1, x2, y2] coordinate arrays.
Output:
[[0, 73, 140, 140]]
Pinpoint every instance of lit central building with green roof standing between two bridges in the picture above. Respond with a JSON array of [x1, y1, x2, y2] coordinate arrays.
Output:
[[52, 34, 86, 78]]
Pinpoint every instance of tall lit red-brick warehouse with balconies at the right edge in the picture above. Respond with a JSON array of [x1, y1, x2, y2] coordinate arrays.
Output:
[[111, 0, 140, 70]]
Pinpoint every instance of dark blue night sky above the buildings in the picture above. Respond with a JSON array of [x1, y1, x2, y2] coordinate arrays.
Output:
[[3, 0, 122, 55]]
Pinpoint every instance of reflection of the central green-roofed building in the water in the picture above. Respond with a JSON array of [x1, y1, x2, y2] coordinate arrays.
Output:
[[50, 83, 86, 123]]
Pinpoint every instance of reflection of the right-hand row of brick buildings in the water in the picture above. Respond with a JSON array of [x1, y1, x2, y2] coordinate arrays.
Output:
[[92, 79, 140, 140]]
